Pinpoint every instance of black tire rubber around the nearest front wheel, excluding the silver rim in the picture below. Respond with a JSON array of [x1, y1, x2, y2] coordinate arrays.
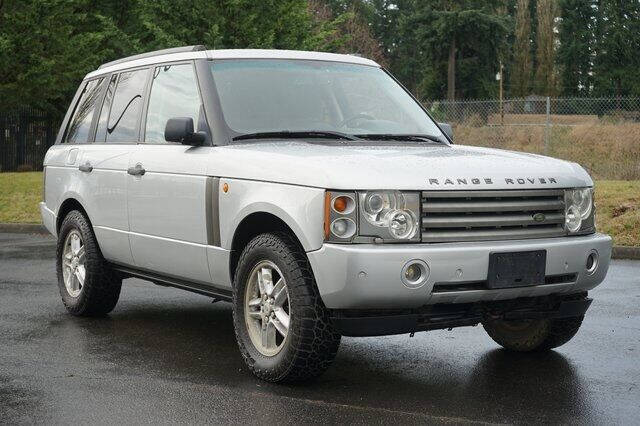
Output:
[[233, 233, 341, 382]]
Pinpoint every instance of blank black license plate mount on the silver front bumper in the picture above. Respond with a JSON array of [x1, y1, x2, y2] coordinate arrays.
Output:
[[487, 250, 547, 289]]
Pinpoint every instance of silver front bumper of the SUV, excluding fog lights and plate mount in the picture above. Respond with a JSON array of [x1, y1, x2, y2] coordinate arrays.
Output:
[[307, 234, 612, 309]]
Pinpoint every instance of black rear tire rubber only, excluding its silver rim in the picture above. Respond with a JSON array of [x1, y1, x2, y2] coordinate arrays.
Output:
[[56, 210, 122, 316]]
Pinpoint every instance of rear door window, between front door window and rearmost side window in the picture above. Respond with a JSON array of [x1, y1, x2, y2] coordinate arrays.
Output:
[[106, 69, 148, 143]]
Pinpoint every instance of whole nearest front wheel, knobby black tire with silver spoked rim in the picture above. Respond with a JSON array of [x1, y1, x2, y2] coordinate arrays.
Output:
[[233, 233, 340, 382]]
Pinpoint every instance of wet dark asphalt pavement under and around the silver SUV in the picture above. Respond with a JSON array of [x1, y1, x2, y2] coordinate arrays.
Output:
[[0, 234, 640, 424]]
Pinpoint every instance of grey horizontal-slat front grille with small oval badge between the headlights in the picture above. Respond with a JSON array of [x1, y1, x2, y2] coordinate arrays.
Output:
[[422, 189, 565, 243]]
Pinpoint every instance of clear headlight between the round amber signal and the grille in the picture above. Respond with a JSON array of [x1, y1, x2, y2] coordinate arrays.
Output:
[[358, 191, 420, 241]]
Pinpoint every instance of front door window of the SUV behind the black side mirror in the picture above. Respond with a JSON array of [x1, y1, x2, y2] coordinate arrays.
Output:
[[145, 64, 201, 143]]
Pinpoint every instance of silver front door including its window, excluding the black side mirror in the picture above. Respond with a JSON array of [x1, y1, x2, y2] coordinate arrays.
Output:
[[127, 62, 211, 284]]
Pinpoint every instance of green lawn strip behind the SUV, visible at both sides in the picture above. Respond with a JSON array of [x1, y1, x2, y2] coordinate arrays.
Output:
[[0, 172, 640, 247]]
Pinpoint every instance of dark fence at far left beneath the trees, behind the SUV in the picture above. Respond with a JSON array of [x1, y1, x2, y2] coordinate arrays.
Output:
[[0, 109, 60, 172]]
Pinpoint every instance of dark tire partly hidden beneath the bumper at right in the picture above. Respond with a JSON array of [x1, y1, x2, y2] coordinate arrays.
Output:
[[482, 315, 584, 352]]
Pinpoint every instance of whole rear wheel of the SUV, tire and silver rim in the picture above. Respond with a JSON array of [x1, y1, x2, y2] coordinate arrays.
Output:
[[56, 210, 122, 316]]
